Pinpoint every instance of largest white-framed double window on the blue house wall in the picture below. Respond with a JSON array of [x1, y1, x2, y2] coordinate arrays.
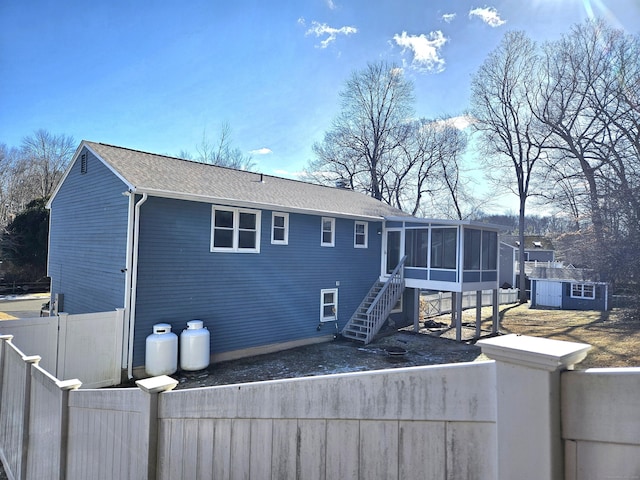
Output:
[[211, 207, 260, 253]]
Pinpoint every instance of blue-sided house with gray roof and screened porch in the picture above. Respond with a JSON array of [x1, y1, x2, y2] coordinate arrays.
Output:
[[48, 141, 498, 377]]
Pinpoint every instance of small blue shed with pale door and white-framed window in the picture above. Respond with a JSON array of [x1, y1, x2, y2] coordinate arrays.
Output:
[[529, 267, 609, 311]]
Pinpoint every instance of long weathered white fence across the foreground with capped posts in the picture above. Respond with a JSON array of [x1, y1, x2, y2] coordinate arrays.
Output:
[[0, 335, 640, 480]]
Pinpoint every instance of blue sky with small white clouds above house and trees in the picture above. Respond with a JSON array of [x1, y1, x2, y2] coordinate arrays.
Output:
[[0, 0, 640, 184]]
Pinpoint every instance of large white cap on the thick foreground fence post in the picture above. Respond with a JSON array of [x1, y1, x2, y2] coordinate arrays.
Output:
[[477, 334, 591, 371]]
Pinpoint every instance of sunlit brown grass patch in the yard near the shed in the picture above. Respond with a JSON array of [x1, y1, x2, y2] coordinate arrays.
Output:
[[462, 304, 640, 369]]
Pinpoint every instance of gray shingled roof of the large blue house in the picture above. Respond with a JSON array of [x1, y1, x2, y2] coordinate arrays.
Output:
[[83, 141, 406, 218]]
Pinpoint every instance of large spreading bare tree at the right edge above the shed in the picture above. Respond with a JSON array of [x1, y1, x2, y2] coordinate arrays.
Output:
[[534, 21, 640, 279]]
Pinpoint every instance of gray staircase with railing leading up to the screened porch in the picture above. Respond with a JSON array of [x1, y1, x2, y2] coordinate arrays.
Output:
[[342, 256, 407, 345]]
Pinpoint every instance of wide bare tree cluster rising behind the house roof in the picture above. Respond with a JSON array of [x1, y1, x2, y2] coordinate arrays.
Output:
[[307, 62, 466, 215]]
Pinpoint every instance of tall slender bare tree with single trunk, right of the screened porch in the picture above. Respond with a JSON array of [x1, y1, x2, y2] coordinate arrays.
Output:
[[471, 32, 545, 303]]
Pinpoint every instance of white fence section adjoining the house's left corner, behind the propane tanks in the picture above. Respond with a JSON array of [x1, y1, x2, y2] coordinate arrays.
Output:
[[0, 309, 124, 388]]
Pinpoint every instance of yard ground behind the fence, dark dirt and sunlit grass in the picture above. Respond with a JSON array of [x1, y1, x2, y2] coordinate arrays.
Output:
[[160, 304, 640, 388]]
